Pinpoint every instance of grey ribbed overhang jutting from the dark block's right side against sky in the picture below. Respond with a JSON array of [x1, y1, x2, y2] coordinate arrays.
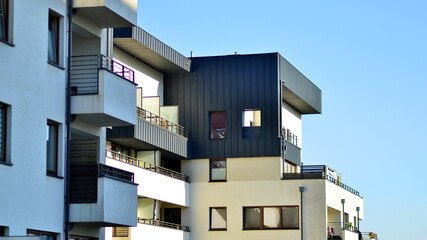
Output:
[[279, 55, 322, 114]]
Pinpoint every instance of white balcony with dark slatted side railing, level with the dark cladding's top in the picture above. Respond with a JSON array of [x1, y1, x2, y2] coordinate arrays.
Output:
[[71, 55, 136, 126]]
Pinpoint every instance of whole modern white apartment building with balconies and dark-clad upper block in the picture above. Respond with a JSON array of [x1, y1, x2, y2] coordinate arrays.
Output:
[[0, 0, 363, 240]]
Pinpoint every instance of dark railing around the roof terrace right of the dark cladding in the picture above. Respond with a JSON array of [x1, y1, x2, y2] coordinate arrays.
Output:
[[282, 165, 360, 197]]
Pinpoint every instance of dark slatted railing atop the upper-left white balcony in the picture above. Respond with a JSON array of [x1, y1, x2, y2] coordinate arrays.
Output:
[[71, 54, 135, 95]]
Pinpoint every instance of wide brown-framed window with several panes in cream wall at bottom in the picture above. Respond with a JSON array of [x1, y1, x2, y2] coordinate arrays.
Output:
[[243, 206, 299, 230]]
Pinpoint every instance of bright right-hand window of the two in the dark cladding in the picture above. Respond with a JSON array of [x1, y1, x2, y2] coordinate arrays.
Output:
[[242, 109, 261, 138]]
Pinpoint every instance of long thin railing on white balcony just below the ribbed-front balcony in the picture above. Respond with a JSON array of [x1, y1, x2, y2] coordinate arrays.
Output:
[[106, 149, 190, 182]]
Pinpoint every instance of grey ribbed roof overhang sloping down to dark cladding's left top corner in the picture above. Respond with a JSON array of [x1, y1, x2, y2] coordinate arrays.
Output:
[[114, 27, 191, 73]]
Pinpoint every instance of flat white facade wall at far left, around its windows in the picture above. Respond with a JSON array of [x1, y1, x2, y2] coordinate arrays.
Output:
[[0, 0, 66, 238]]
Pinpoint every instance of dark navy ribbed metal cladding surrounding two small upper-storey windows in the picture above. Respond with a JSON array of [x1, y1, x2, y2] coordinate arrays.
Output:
[[164, 53, 281, 159]]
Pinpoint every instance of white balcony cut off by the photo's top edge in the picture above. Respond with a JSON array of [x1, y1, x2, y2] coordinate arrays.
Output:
[[73, 0, 138, 28]]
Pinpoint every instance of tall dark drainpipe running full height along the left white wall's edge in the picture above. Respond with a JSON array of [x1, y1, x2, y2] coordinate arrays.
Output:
[[64, 0, 73, 240]]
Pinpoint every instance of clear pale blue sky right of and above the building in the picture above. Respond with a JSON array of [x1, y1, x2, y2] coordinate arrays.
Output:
[[138, 0, 427, 240]]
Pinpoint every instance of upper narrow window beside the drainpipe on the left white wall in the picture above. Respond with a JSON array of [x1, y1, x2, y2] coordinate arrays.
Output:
[[48, 11, 59, 64]]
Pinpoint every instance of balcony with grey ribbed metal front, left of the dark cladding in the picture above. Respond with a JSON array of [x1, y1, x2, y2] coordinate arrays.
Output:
[[107, 108, 188, 160]]
